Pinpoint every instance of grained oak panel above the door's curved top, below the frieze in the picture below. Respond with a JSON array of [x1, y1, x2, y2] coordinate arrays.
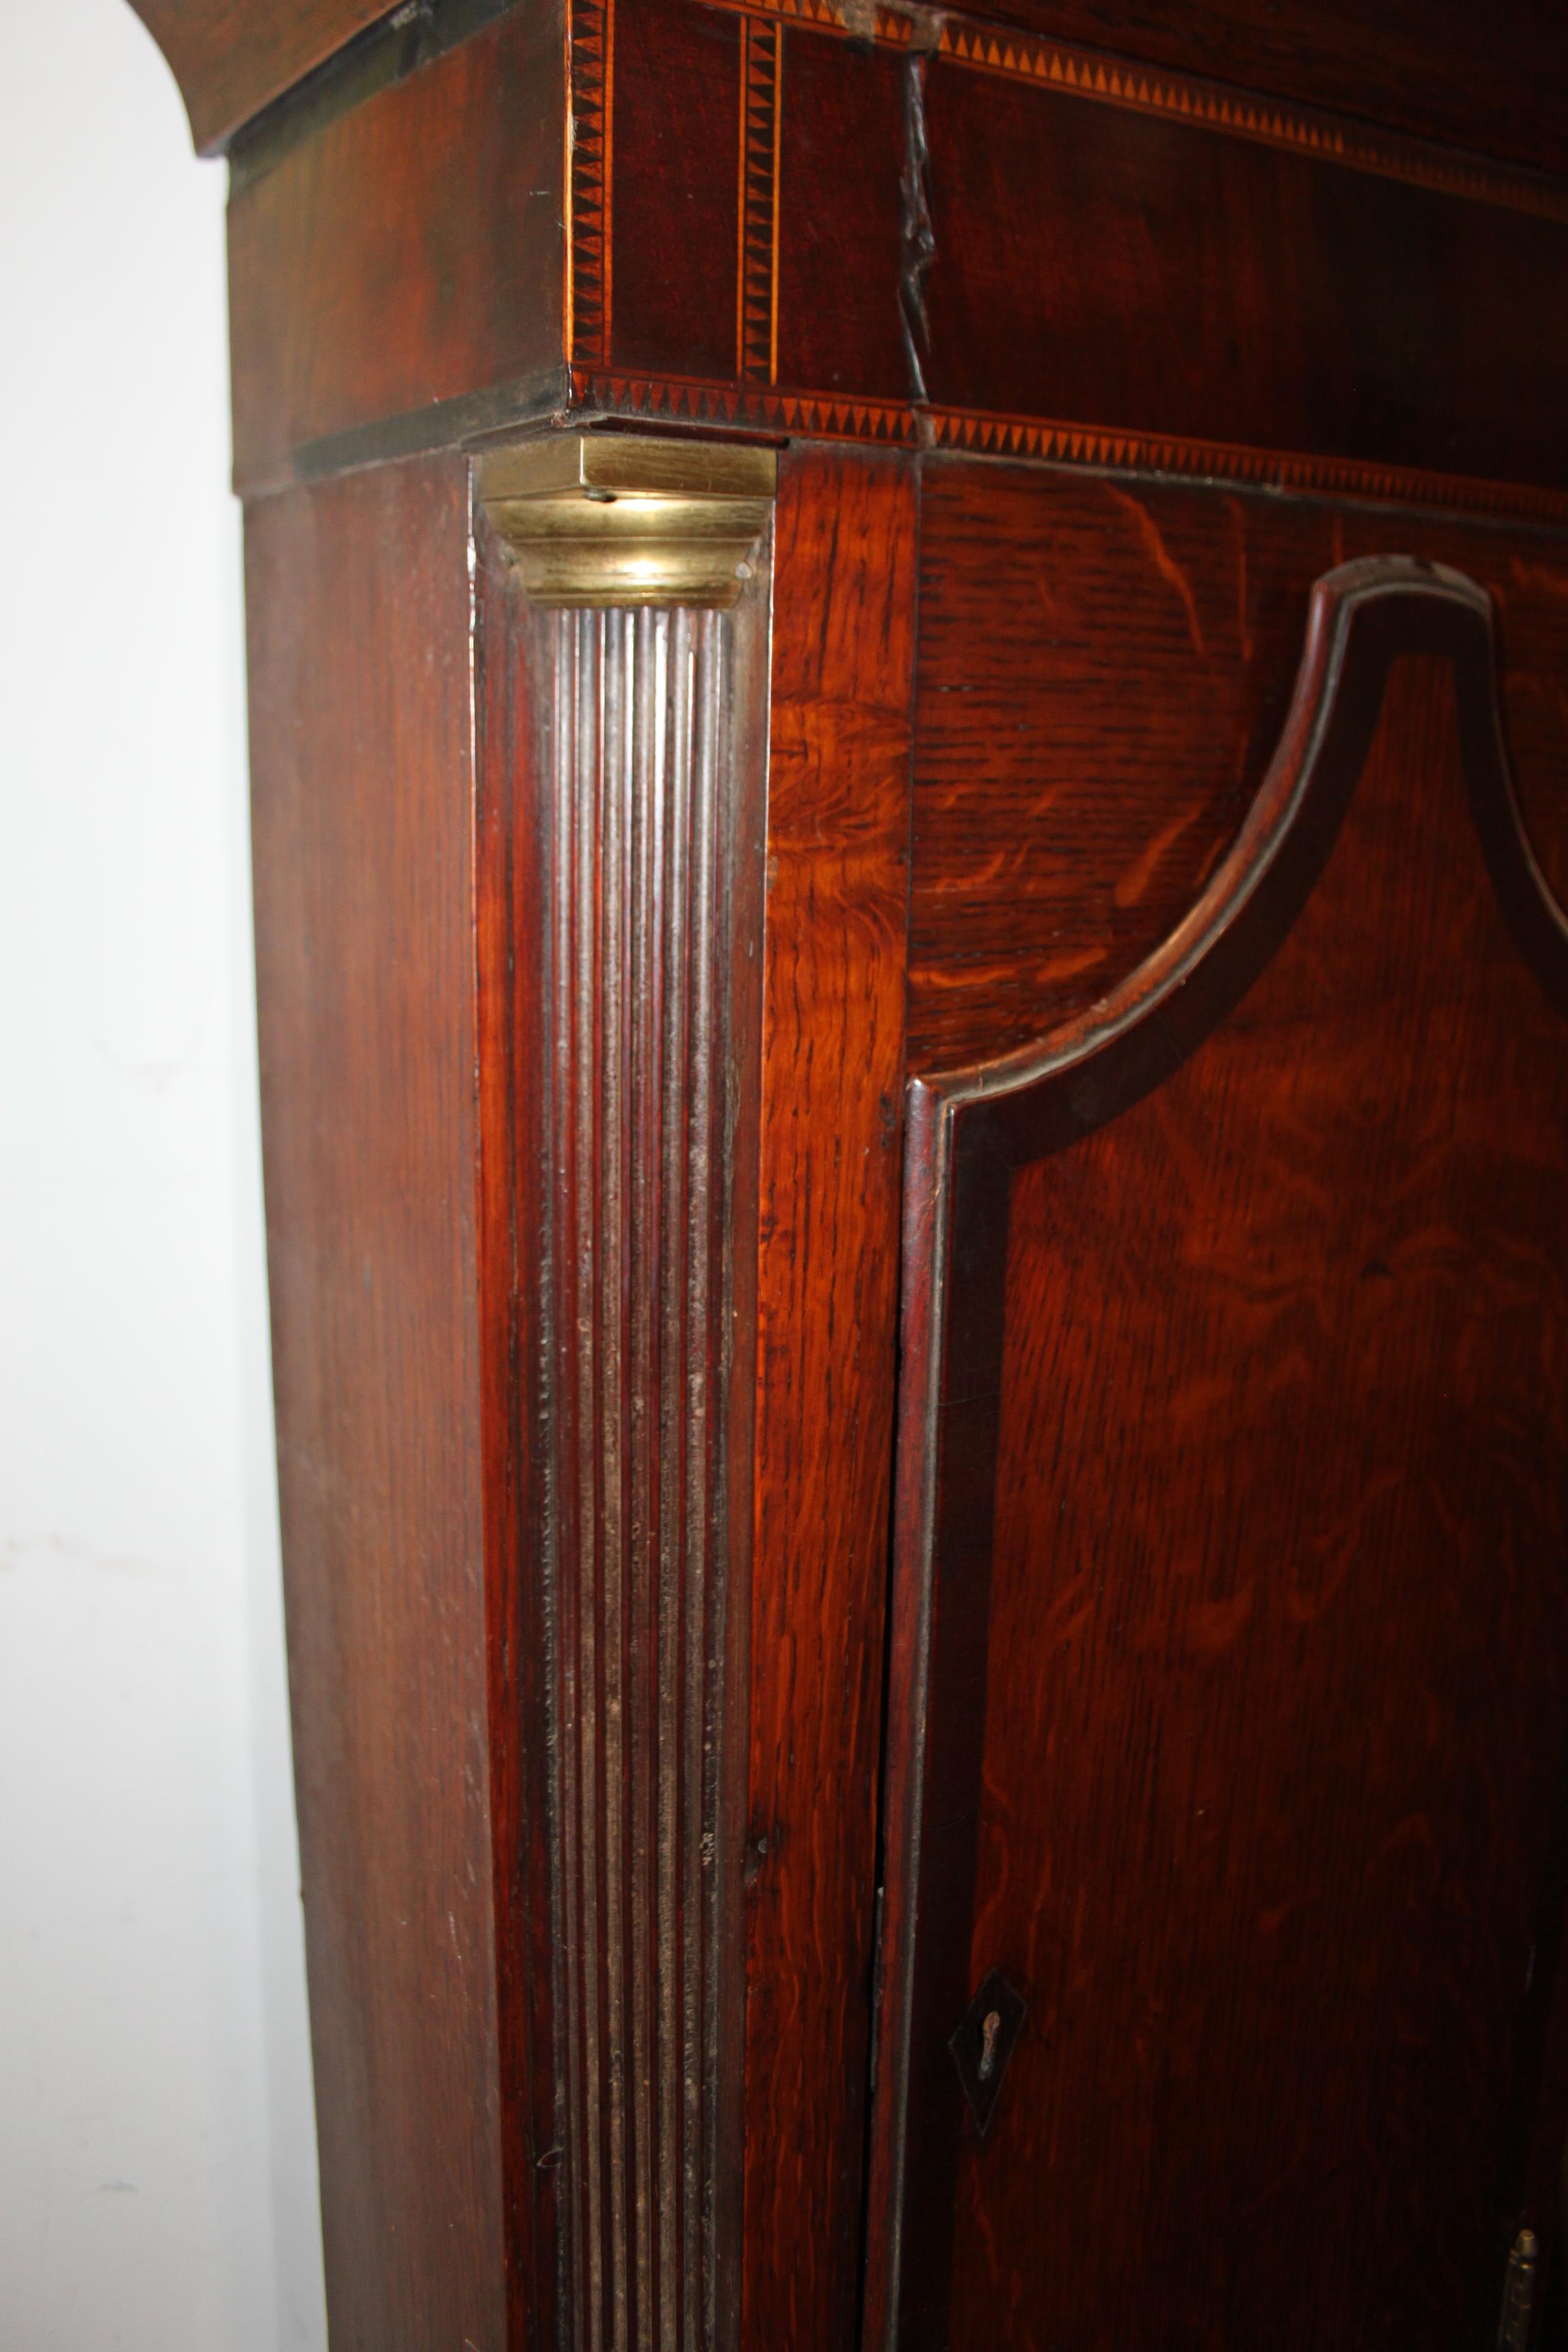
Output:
[[910, 459, 1568, 1070]]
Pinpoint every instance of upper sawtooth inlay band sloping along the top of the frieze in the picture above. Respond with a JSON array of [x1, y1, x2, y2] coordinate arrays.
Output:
[[708, 0, 1568, 221]]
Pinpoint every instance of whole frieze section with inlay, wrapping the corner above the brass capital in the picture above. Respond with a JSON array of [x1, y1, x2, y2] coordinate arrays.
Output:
[[233, 0, 1568, 536]]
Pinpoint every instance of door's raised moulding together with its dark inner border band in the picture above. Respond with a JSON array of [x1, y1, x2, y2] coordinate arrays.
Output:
[[868, 557, 1568, 2352]]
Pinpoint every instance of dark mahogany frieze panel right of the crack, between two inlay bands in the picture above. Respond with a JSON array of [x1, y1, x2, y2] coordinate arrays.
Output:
[[921, 59, 1568, 487]]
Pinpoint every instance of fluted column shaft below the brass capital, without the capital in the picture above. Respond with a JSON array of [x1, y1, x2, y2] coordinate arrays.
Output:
[[536, 574, 766, 2352]]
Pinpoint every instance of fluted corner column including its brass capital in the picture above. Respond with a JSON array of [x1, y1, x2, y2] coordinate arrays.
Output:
[[480, 442, 771, 2352]]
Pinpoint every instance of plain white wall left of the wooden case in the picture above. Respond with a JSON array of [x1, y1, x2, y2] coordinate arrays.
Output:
[[0, 0, 325, 2352]]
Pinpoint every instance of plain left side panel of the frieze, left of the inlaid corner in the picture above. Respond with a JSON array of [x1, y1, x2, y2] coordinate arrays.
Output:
[[228, 0, 566, 487]]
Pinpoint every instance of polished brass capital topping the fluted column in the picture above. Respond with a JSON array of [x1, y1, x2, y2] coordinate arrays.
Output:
[[480, 433, 778, 612]]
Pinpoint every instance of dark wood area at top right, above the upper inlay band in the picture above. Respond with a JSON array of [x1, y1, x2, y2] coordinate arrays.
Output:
[[983, 0, 1568, 172]]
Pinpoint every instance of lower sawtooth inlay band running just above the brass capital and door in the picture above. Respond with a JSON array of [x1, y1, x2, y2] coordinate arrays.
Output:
[[571, 374, 1568, 529]]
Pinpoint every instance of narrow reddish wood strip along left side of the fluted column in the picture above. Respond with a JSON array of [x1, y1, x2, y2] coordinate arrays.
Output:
[[475, 510, 574, 2352]]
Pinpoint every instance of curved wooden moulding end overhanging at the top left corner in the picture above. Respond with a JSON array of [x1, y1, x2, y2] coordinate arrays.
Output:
[[131, 0, 388, 155]]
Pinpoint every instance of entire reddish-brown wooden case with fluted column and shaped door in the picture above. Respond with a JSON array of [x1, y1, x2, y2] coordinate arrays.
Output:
[[131, 0, 1568, 2352]]
